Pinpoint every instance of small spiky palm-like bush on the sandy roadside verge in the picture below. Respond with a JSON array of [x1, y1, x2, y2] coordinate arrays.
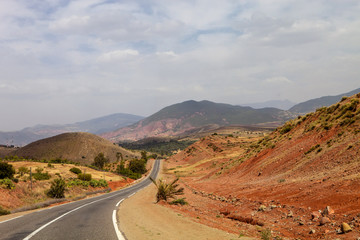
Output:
[[150, 177, 184, 202]]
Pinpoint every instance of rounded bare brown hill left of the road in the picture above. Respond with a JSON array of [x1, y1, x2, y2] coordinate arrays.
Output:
[[11, 133, 138, 164]]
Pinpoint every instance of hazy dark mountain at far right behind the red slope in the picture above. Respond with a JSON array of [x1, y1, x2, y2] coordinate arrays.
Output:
[[289, 88, 360, 114]]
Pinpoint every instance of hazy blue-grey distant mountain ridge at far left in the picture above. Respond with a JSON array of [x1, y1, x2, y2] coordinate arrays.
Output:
[[0, 113, 143, 146]]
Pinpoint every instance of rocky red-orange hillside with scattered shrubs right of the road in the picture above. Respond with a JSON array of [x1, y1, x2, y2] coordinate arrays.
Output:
[[165, 94, 360, 239]]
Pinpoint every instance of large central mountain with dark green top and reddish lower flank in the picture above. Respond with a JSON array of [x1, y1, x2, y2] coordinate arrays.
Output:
[[101, 100, 292, 142]]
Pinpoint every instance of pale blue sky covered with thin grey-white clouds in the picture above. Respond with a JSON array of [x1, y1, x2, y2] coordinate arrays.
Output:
[[0, 0, 360, 131]]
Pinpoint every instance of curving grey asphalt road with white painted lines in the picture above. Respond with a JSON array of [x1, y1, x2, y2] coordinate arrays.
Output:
[[0, 160, 160, 240]]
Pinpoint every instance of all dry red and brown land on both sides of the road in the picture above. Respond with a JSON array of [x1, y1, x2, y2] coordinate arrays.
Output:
[[0, 91, 360, 239]]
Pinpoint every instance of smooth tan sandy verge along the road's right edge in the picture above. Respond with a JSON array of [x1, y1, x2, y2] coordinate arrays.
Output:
[[118, 185, 252, 240]]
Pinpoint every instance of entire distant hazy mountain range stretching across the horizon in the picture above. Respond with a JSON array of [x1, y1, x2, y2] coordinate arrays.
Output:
[[0, 88, 360, 146]]
